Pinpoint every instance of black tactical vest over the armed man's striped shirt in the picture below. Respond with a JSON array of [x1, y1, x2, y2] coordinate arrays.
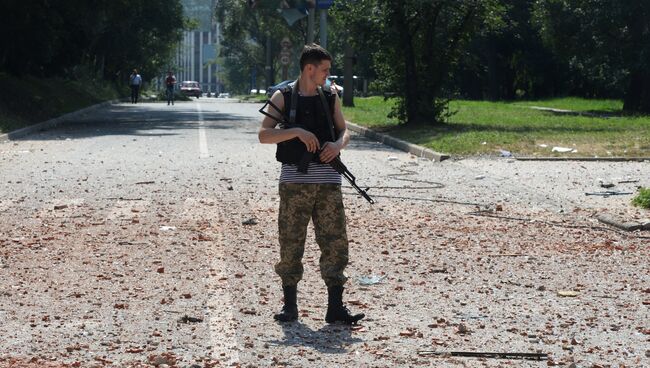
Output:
[[275, 86, 338, 164]]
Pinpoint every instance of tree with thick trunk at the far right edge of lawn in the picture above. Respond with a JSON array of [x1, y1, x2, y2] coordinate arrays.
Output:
[[536, 0, 650, 113]]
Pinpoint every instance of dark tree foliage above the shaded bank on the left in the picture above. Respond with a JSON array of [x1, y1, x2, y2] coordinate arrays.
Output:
[[0, 0, 184, 79]]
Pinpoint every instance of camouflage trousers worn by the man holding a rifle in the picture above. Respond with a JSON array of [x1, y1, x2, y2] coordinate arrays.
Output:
[[275, 183, 348, 287]]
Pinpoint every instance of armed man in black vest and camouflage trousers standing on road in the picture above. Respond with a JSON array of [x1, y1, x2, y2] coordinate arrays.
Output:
[[259, 44, 365, 324]]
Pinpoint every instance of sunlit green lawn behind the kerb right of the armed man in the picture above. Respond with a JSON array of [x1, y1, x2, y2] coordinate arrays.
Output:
[[344, 97, 650, 157]]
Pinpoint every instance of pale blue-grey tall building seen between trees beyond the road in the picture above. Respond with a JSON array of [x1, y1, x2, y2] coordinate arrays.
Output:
[[171, 0, 223, 93]]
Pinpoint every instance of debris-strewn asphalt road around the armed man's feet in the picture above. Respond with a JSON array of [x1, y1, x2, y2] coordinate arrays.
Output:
[[0, 99, 650, 367]]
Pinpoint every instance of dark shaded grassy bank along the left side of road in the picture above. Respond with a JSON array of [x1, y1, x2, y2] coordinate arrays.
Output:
[[0, 73, 119, 133]]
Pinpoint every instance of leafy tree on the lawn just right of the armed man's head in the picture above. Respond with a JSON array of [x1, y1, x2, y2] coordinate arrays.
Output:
[[339, 0, 503, 124]]
